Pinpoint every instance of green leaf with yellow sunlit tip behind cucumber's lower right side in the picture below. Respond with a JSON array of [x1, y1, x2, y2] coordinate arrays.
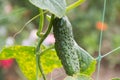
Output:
[[78, 46, 96, 76]]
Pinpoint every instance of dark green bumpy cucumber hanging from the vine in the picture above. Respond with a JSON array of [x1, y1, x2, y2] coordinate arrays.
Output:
[[53, 17, 80, 75]]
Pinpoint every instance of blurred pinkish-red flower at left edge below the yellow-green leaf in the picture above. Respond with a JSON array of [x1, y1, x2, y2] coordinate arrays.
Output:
[[0, 59, 14, 69]]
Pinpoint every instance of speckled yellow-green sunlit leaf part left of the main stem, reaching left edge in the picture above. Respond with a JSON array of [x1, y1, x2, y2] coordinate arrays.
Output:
[[0, 46, 36, 80]]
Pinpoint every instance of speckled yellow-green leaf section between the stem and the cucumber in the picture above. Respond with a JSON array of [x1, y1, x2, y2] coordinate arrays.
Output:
[[41, 49, 62, 74]]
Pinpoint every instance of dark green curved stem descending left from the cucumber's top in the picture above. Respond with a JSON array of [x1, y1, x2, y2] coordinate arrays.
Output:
[[36, 14, 54, 52]]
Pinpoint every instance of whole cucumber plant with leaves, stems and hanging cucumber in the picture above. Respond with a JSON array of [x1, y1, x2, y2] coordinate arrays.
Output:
[[0, 0, 120, 80]]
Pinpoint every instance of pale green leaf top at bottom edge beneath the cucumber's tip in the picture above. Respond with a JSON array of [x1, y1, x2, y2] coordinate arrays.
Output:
[[64, 74, 93, 80]]
